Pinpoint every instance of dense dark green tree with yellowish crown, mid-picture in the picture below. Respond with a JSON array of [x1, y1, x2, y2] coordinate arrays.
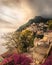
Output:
[[19, 30, 34, 52]]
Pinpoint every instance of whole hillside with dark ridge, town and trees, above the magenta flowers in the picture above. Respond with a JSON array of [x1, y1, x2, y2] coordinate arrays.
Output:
[[2, 16, 52, 65]]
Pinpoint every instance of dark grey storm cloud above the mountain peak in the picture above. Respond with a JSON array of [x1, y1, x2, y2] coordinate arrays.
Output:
[[27, 0, 52, 17]]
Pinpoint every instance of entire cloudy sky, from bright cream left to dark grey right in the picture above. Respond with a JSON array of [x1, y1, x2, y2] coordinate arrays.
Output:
[[0, 0, 52, 54]]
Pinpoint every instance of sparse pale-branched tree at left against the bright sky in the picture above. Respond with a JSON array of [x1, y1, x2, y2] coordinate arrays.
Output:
[[2, 32, 20, 52]]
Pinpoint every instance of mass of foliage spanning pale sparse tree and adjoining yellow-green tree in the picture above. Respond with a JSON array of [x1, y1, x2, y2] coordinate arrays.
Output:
[[3, 30, 34, 53]]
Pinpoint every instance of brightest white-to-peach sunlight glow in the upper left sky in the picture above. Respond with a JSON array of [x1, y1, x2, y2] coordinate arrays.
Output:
[[0, 6, 32, 25]]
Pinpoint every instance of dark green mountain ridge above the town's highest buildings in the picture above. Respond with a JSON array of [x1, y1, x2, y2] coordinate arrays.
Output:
[[17, 16, 52, 31]]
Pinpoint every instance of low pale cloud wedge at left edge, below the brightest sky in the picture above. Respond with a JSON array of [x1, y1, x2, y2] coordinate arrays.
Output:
[[0, 19, 17, 30]]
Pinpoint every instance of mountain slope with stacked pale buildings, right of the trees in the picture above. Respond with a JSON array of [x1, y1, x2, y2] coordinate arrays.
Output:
[[17, 16, 52, 65]]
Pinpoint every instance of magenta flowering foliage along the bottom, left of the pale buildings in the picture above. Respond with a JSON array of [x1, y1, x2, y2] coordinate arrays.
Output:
[[1, 54, 32, 65]]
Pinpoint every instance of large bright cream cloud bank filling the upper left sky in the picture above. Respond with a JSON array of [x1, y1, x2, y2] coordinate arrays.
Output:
[[0, 0, 33, 28]]
